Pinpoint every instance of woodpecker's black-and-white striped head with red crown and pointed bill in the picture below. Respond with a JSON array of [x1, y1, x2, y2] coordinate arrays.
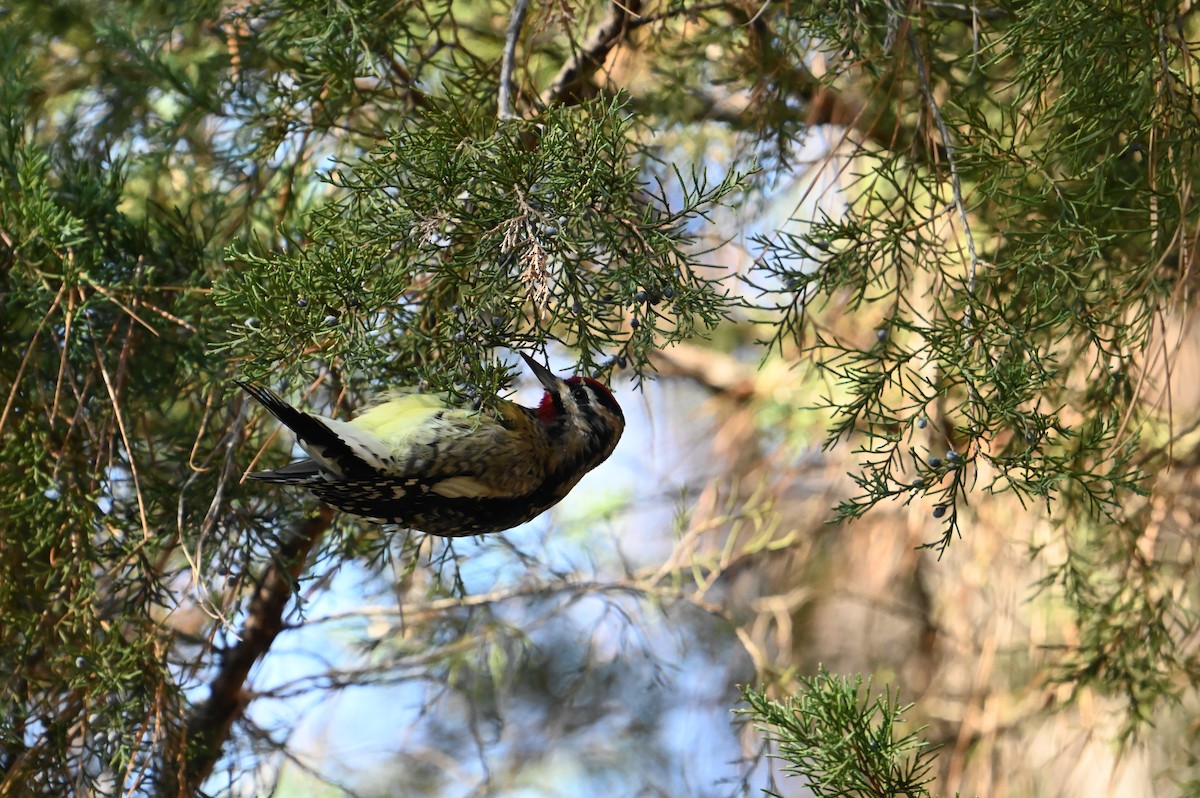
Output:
[[520, 352, 625, 468]]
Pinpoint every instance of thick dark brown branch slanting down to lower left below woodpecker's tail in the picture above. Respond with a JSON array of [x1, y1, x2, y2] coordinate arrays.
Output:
[[169, 505, 334, 796]]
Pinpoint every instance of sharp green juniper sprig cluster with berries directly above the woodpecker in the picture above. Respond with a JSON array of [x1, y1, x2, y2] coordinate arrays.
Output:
[[214, 102, 738, 396]]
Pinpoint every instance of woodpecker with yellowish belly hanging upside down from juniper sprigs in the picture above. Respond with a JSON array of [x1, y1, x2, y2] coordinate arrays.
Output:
[[238, 353, 625, 538]]
